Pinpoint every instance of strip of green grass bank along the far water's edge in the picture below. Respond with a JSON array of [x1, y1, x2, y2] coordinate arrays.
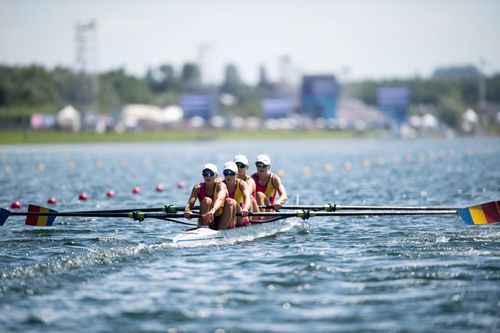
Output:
[[0, 129, 385, 145]]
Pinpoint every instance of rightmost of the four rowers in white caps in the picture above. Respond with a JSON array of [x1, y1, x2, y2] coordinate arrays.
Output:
[[252, 154, 288, 211]]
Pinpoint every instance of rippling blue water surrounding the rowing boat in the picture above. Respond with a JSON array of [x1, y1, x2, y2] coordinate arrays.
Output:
[[0, 139, 500, 332]]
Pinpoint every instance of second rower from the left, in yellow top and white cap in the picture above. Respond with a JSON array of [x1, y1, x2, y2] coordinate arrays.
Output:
[[223, 162, 252, 226]]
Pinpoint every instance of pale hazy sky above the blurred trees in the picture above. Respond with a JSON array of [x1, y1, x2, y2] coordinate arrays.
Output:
[[0, 0, 500, 83]]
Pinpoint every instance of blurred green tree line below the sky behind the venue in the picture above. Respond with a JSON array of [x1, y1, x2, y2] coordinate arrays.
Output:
[[0, 63, 500, 127]]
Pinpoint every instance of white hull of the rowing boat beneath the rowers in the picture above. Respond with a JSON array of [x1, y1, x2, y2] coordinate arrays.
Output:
[[172, 218, 300, 247]]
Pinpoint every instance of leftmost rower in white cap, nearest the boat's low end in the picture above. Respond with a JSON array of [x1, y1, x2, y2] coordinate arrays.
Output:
[[184, 163, 236, 230]]
